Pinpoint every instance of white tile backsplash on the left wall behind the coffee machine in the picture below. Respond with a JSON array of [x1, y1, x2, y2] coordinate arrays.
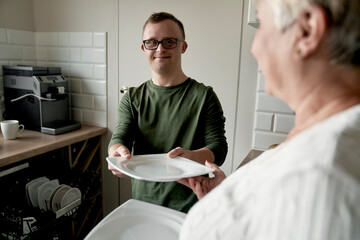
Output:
[[0, 28, 107, 127]]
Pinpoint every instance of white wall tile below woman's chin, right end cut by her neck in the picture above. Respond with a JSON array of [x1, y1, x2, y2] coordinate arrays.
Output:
[[257, 92, 293, 114]]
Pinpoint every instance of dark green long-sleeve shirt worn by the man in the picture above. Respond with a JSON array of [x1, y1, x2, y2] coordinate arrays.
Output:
[[109, 78, 227, 212]]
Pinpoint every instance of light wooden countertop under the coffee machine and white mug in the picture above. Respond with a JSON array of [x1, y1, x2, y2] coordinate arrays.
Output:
[[0, 124, 107, 167]]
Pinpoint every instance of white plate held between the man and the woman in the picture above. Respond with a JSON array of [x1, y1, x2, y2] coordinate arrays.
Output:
[[106, 154, 214, 182]]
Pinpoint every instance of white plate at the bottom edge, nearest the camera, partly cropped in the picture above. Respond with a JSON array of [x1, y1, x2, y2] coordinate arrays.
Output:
[[85, 199, 186, 240]]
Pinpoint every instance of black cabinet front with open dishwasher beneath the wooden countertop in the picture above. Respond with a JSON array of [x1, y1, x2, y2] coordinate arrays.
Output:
[[0, 137, 103, 240]]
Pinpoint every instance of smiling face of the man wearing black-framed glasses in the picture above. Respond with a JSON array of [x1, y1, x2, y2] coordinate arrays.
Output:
[[141, 20, 187, 74]]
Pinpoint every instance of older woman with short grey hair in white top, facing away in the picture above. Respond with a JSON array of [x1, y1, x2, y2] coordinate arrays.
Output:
[[179, 0, 360, 240]]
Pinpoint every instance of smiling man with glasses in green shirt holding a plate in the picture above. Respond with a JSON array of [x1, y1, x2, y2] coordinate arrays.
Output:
[[108, 12, 227, 212]]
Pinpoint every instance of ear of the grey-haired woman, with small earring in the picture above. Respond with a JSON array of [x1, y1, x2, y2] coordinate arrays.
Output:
[[296, 5, 328, 57]]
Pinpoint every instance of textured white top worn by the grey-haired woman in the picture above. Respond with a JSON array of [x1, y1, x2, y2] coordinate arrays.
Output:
[[180, 105, 360, 240]]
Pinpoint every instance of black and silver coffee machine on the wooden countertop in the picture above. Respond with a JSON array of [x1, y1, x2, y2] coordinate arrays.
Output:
[[3, 65, 81, 135]]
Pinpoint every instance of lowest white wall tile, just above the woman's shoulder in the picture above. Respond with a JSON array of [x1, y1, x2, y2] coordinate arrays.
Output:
[[253, 131, 287, 150]]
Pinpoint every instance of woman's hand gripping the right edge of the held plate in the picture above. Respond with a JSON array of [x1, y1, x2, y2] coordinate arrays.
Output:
[[177, 161, 226, 199]]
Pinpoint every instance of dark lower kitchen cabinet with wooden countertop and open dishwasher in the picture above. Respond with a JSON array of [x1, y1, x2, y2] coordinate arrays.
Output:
[[0, 125, 107, 239]]
